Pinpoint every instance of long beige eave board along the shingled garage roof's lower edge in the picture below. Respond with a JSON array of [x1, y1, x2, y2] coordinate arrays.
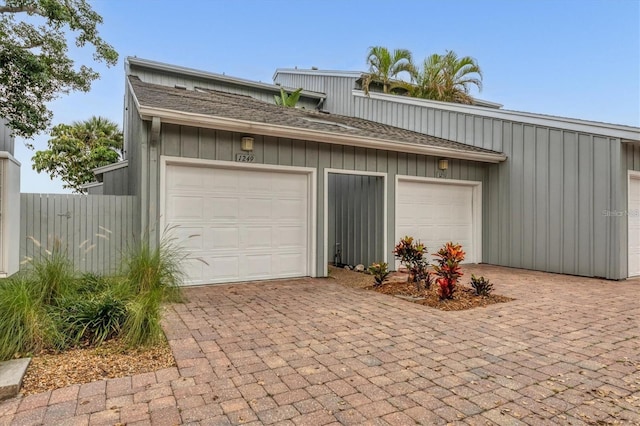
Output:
[[138, 106, 507, 163]]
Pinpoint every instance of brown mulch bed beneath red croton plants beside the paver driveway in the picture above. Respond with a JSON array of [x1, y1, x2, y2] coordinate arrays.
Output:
[[329, 266, 513, 311]]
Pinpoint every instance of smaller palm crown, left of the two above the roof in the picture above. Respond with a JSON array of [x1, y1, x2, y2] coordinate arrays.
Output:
[[362, 46, 414, 93]]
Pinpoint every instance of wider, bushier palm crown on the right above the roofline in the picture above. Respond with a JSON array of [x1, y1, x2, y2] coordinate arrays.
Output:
[[411, 51, 482, 104]]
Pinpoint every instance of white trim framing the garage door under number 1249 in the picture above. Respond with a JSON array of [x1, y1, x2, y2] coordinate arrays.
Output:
[[159, 155, 317, 277]]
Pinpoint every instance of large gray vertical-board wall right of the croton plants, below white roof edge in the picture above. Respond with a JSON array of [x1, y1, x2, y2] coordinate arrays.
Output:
[[353, 96, 627, 279]]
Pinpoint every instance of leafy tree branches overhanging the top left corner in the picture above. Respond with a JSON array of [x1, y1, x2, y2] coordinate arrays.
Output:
[[0, 0, 118, 138]]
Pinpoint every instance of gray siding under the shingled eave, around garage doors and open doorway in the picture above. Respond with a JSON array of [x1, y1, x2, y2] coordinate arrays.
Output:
[[142, 122, 487, 276]]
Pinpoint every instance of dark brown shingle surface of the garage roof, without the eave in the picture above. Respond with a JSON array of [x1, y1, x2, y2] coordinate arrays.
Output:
[[128, 76, 501, 160]]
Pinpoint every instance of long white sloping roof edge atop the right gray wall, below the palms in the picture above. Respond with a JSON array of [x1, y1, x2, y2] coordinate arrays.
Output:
[[352, 90, 640, 142]]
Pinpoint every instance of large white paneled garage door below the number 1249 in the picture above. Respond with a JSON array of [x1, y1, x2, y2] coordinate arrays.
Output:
[[165, 164, 310, 284]]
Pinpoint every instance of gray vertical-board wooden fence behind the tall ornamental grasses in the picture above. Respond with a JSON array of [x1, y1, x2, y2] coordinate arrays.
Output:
[[20, 193, 136, 273]]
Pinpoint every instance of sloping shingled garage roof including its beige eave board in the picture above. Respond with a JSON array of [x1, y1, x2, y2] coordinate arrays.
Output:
[[128, 76, 506, 163]]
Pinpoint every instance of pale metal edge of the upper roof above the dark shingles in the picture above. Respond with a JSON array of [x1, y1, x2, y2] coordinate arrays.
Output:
[[125, 56, 326, 99]]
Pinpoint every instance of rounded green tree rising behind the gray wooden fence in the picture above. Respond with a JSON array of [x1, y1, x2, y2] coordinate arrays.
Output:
[[32, 117, 123, 192]]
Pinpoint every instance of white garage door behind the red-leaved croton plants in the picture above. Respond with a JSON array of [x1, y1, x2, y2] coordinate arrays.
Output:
[[396, 180, 480, 263]]
